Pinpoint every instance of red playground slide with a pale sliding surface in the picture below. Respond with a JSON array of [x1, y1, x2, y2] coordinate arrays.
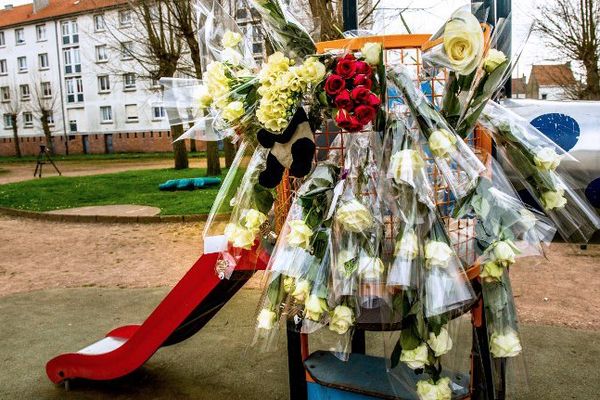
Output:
[[46, 253, 268, 383]]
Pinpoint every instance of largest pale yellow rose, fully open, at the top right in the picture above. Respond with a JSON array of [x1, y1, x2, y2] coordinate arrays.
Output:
[[444, 10, 484, 75]]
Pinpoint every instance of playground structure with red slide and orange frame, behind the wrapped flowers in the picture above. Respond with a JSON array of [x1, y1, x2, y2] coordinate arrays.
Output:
[[46, 35, 504, 400]]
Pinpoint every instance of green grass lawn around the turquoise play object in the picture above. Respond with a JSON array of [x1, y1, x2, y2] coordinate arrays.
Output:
[[0, 168, 227, 215]]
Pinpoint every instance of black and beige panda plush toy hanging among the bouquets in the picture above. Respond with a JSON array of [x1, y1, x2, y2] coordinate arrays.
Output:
[[256, 107, 315, 189]]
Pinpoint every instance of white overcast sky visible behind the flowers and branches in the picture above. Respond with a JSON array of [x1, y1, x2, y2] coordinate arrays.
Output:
[[0, 0, 564, 76]]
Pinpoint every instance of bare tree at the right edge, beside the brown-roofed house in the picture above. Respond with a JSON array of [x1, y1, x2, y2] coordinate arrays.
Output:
[[535, 0, 600, 100]]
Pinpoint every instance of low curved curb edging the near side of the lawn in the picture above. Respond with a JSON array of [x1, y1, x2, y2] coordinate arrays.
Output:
[[0, 207, 228, 224]]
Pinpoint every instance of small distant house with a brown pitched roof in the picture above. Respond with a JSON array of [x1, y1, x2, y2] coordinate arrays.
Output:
[[527, 63, 578, 100]]
